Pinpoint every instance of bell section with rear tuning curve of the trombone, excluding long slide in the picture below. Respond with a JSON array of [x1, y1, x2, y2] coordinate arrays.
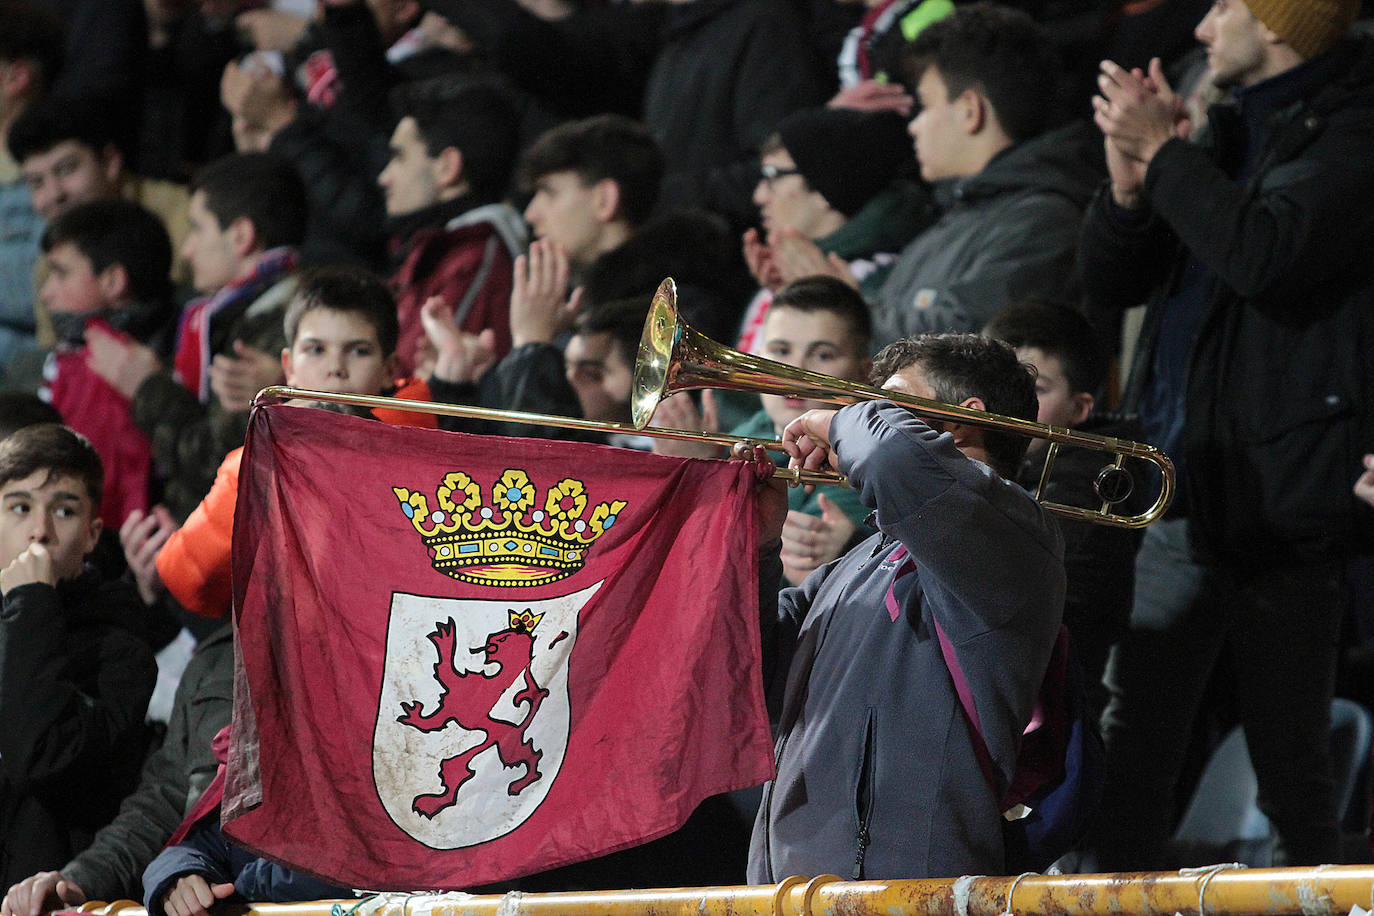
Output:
[[631, 277, 1175, 527]]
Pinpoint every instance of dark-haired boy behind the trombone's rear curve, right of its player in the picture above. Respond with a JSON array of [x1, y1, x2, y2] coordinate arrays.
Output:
[[982, 301, 1145, 713]]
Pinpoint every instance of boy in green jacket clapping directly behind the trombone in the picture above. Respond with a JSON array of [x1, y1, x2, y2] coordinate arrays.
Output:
[[654, 276, 872, 585]]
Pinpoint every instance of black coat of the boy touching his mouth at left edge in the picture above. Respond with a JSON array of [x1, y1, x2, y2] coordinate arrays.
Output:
[[0, 567, 157, 887]]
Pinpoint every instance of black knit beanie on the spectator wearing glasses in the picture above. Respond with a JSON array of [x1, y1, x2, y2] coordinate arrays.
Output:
[[778, 108, 915, 217]]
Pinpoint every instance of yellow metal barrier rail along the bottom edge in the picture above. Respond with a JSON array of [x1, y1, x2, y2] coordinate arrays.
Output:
[[66, 865, 1374, 916]]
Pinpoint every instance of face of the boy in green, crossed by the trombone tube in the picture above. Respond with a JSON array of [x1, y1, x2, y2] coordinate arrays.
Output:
[[758, 305, 868, 430]]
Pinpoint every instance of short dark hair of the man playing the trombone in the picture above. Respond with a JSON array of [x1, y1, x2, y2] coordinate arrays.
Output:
[[871, 334, 1039, 479]]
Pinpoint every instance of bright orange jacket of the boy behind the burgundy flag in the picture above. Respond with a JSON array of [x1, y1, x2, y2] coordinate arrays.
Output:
[[157, 379, 437, 618]]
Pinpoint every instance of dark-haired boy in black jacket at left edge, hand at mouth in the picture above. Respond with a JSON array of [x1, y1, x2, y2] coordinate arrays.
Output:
[[0, 424, 157, 887]]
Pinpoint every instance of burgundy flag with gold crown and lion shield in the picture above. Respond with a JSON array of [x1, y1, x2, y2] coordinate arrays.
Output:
[[223, 407, 772, 890]]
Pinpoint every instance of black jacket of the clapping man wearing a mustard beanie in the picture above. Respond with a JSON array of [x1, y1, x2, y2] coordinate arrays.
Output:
[[1080, 41, 1374, 564]]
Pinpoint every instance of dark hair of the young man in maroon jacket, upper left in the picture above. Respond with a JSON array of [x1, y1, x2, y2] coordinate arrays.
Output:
[[392, 76, 519, 202]]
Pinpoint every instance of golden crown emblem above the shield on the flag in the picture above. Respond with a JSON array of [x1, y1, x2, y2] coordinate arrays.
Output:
[[392, 468, 627, 586]]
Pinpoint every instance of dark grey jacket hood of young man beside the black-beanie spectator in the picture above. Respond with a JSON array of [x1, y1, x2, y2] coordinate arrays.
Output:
[[936, 121, 1106, 210]]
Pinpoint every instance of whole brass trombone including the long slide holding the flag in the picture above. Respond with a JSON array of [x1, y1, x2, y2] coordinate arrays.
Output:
[[253, 279, 1173, 527]]
